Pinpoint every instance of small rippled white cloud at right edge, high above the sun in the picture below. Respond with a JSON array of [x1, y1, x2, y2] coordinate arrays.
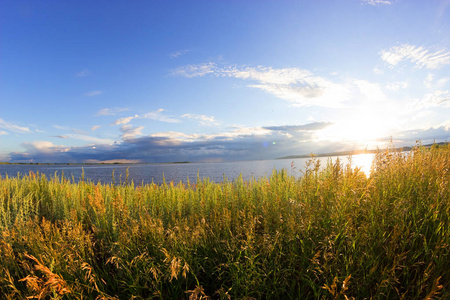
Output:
[[380, 44, 450, 69]]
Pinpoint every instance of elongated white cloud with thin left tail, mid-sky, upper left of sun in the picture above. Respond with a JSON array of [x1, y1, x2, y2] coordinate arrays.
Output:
[[172, 63, 350, 107]]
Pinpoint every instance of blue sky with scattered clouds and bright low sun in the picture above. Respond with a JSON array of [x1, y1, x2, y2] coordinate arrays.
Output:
[[0, 0, 450, 163]]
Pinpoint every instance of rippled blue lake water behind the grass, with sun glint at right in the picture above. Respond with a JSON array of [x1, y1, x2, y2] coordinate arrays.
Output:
[[0, 154, 374, 184]]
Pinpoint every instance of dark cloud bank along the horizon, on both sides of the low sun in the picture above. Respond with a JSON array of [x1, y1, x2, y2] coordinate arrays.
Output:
[[5, 122, 450, 163]]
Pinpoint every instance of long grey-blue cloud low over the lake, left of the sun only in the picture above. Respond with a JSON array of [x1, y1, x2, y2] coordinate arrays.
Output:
[[5, 124, 330, 162]]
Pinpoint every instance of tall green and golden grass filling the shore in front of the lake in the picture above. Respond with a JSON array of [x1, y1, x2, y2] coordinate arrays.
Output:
[[0, 145, 450, 299]]
